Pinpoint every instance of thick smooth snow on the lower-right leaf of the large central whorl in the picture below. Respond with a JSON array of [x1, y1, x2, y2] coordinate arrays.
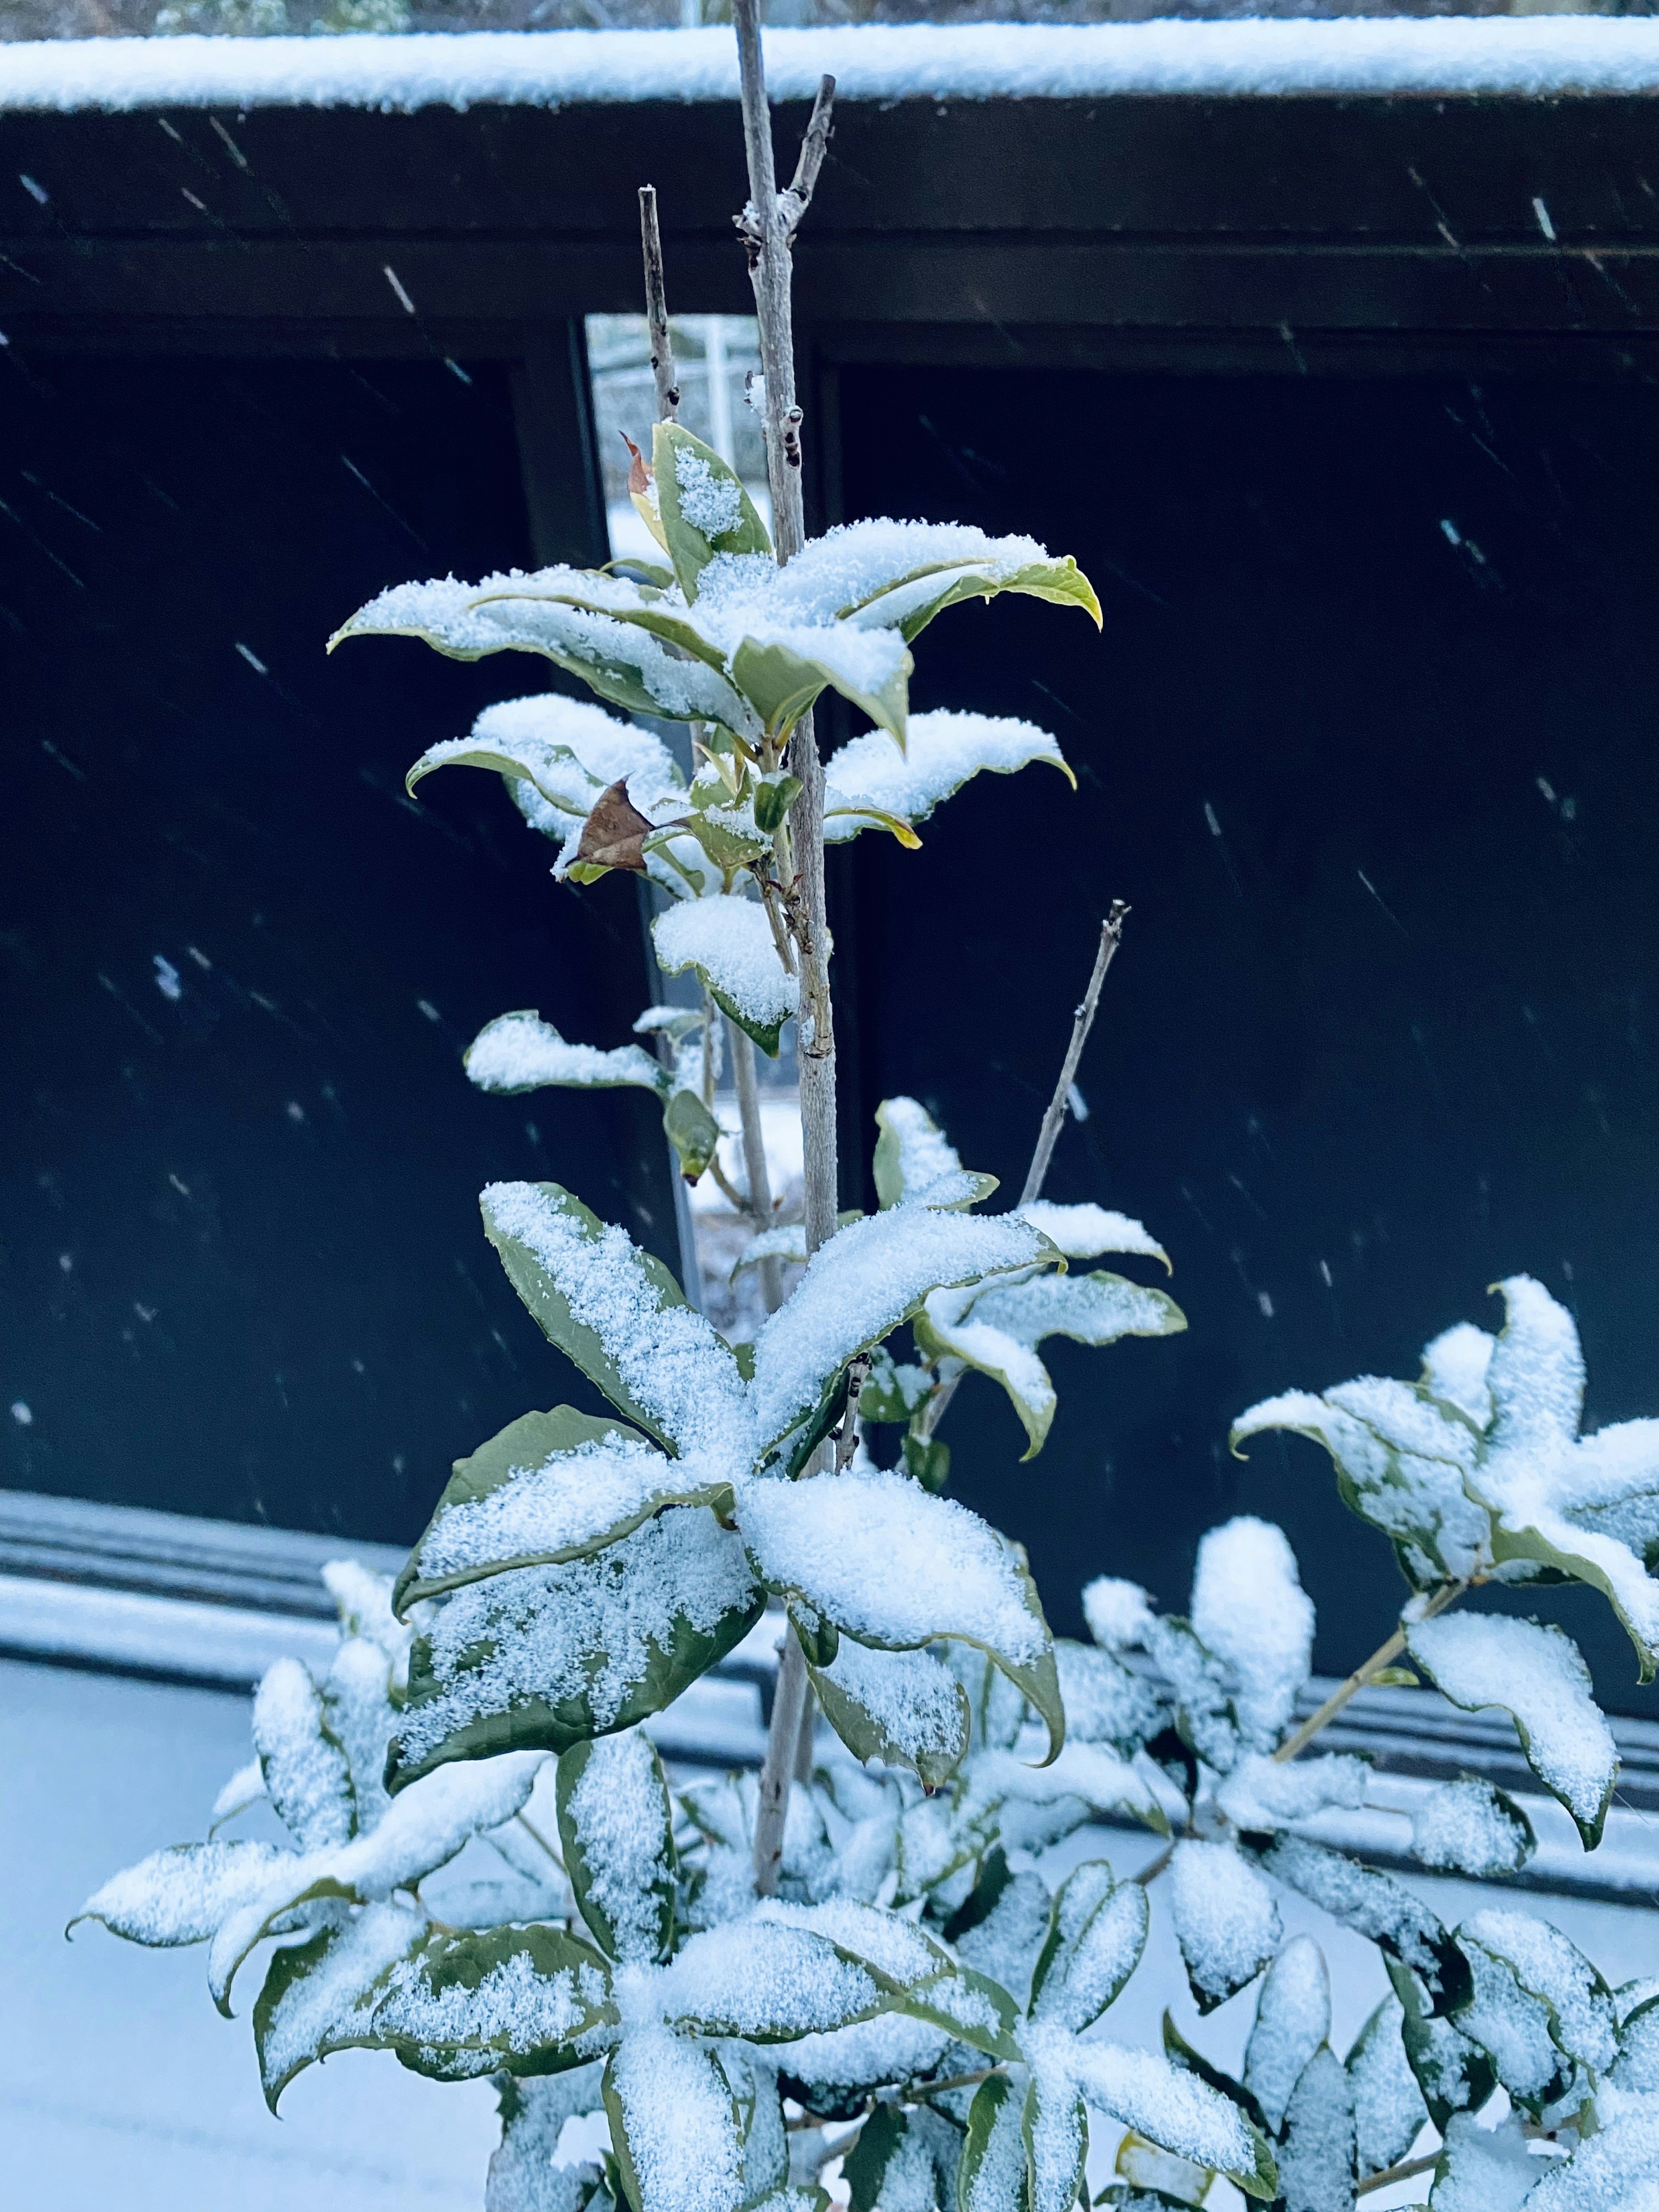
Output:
[[739, 1468, 1066, 1756]]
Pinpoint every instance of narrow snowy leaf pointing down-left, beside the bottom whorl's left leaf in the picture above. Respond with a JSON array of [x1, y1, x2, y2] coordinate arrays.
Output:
[[254, 1904, 427, 2113]]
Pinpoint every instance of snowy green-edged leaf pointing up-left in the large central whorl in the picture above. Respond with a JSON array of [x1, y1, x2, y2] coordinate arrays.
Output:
[[480, 1183, 748, 1451]]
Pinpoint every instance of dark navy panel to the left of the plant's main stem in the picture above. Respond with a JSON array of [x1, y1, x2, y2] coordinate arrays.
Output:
[[0, 361, 672, 1540]]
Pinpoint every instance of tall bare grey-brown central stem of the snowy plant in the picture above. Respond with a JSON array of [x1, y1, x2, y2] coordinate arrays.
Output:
[[732, 0, 838, 1898]]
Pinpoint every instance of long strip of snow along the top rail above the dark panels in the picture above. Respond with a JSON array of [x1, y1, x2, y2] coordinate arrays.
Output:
[[0, 16, 1659, 113]]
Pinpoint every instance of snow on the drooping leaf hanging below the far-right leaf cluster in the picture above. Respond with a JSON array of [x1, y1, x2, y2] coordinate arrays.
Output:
[[1407, 1612, 1619, 1851]]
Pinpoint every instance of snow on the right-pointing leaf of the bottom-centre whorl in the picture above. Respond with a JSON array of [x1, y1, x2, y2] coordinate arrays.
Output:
[[652, 1918, 889, 2035]]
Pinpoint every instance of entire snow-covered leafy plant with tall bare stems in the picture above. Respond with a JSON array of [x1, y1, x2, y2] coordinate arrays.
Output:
[[82, 17, 1659, 2212]]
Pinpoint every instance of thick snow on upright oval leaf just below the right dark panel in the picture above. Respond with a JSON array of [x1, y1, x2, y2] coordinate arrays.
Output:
[[1192, 1513, 1314, 1752]]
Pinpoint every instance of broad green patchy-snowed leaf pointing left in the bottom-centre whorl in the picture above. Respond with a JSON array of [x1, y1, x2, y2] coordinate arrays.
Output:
[[369, 1922, 617, 2082]]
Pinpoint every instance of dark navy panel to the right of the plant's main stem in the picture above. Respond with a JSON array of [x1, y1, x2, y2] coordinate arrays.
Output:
[[841, 369, 1659, 1706]]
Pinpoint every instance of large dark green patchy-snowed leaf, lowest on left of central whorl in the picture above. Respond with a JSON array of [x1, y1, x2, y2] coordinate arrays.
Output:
[[387, 1506, 766, 1792]]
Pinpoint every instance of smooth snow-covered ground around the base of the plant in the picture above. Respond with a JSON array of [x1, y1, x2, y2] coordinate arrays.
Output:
[[0, 1661, 1659, 2212]]
